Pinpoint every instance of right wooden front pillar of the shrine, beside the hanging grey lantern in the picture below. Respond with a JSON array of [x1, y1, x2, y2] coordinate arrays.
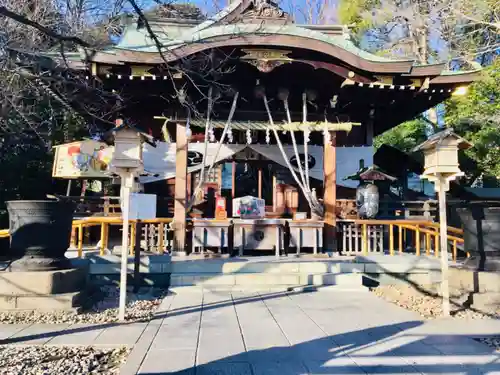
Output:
[[323, 132, 337, 252]]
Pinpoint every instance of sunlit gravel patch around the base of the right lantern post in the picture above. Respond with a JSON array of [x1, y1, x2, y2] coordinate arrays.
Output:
[[372, 285, 500, 319]]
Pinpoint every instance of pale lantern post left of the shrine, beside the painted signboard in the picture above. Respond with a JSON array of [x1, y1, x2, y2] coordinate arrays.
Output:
[[110, 119, 148, 321]]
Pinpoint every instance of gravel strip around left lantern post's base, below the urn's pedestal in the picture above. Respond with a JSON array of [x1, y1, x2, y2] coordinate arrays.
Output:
[[0, 286, 165, 324]]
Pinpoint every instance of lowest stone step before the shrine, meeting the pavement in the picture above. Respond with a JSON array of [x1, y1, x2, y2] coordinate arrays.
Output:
[[170, 273, 362, 287]]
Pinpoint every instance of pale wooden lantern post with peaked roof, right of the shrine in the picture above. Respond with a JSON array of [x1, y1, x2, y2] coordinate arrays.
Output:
[[413, 129, 472, 316]]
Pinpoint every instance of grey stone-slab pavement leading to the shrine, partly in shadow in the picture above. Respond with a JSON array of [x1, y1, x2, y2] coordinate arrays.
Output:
[[0, 288, 500, 375]]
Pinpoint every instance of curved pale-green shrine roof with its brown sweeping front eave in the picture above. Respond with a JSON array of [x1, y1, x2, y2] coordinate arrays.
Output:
[[73, 0, 478, 83]]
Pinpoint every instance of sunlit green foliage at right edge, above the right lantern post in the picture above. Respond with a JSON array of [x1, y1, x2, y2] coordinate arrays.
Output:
[[446, 57, 500, 184]]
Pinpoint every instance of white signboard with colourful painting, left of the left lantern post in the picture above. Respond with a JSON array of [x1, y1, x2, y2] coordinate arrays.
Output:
[[52, 140, 113, 179]]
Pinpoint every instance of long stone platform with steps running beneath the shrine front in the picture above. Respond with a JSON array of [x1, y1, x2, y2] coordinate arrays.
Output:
[[63, 252, 450, 290]]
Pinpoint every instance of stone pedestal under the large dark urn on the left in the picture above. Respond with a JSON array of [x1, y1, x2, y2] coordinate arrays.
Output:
[[0, 268, 87, 311]]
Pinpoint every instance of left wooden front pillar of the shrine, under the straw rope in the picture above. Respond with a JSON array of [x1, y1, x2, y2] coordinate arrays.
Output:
[[174, 123, 188, 255]]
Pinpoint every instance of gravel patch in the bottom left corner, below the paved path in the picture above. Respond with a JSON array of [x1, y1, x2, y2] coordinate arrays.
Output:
[[0, 346, 129, 375]]
